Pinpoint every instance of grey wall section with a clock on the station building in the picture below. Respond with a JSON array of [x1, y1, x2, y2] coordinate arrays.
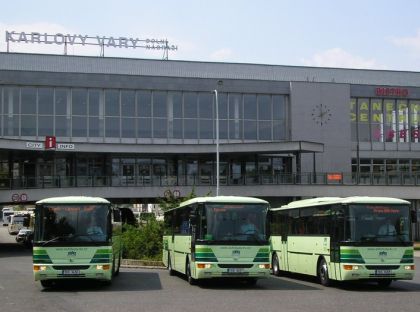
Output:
[[290, 82, 351, 172]]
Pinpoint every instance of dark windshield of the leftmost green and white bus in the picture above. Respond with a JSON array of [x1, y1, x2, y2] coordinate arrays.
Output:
[[34, 204, 109, 245]]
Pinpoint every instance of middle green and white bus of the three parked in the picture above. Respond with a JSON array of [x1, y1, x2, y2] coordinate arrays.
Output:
[[163, 196, 270, 285]]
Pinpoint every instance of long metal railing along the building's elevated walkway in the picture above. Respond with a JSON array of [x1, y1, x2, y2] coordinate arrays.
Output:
[[0, 172, 420, 189]]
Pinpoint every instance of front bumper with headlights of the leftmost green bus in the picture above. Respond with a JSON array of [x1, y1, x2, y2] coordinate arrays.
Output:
[[33, 264, 112, 281]]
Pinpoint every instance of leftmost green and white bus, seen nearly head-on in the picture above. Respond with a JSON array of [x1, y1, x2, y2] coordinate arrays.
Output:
[[33, 196, 122, 287]]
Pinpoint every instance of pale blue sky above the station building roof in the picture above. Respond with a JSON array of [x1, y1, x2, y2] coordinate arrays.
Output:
[[0, 0, 420, 71]]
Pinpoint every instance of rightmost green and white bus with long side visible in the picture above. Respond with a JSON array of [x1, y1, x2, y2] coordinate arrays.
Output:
[[269, 196, 416, 287]]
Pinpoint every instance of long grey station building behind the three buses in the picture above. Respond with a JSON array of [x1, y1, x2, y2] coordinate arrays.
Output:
[[0, 53, 420, 239]]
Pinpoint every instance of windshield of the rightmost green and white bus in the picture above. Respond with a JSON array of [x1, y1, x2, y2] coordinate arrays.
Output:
[[346, 204, 410, 243]]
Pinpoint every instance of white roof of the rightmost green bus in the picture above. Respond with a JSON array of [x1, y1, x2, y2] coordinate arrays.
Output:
[[271, 196, 410, 210]]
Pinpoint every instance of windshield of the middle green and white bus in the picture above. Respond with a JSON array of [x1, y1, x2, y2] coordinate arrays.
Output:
[[201, 203, 268, 242]]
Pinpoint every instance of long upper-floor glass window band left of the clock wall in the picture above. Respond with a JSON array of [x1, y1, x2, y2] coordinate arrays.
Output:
[[0, 86, 288, 143]]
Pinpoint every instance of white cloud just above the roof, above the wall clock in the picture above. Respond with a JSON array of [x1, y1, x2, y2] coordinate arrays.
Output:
[[302, 48, 385, 69]]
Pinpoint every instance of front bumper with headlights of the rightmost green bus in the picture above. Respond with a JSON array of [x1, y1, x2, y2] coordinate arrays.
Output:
[[341, 264, 415, 281]]
